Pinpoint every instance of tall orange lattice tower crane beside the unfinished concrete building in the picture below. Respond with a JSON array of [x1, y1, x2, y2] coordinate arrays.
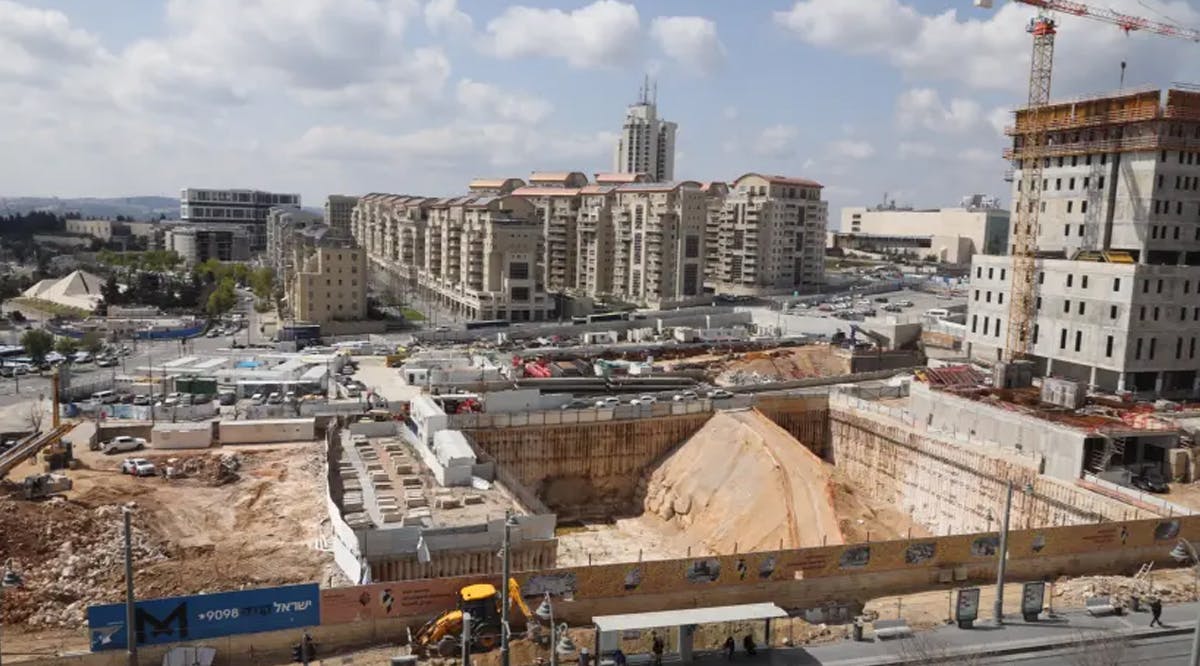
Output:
[[974, 0, 1200, 361]]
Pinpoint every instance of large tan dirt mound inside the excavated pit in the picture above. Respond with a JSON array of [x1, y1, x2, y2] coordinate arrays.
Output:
[[641, 410, 842, 554]]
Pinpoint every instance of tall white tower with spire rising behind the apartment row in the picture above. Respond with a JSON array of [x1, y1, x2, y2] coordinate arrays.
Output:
[[612, 82, 678, 182]]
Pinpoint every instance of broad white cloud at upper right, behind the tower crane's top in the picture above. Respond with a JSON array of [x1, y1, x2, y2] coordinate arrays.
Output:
[[774, 0, 1200, 94]]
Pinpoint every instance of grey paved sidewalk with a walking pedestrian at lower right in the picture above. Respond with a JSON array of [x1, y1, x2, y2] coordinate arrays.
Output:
[[702, 602, 1200, 666]]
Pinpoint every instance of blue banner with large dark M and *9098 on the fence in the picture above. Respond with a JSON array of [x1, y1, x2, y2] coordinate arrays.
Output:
[[88, 583, 320, 652]]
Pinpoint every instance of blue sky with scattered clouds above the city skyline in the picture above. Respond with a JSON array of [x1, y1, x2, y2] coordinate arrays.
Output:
[[0, 0, 1200, 221]]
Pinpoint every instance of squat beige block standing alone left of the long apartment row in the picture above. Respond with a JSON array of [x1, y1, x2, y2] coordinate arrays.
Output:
[[287, 244, 367, 324]]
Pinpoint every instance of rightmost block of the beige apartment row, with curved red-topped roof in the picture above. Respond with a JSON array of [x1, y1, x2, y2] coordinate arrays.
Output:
[[708, 174, 828, 294]]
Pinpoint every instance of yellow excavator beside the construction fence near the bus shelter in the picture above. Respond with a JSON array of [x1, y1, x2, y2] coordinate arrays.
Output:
[[409, 578, 533, 659]]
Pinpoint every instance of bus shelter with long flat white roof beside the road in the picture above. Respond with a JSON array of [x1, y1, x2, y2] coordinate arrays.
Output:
[[592, 604, 787, 664]]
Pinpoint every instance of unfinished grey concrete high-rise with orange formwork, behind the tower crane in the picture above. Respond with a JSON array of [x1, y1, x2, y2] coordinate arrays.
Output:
[[966, 90, 1200, 397]]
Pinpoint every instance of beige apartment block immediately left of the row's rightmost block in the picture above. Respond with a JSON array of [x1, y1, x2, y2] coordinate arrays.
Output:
[[612, 181, 708, 306]]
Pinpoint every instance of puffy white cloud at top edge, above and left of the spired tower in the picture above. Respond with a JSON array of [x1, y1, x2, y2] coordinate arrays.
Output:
[[485, 0, 642, 67]]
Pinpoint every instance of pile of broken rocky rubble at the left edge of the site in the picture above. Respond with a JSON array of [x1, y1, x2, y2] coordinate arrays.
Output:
[[0, 498, 167, 628]]
